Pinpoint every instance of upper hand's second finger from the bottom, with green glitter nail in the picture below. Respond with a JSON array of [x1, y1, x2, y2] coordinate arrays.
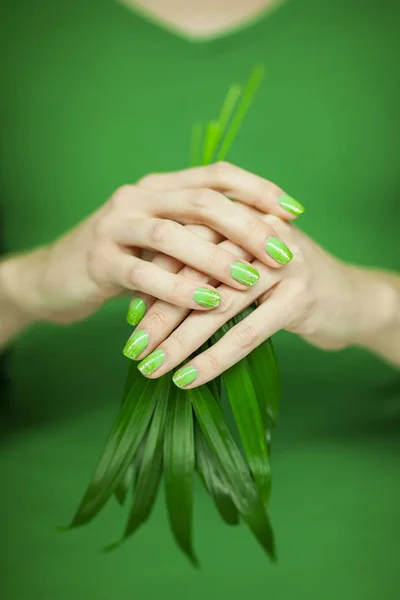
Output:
[[108, 216, 259, 290]]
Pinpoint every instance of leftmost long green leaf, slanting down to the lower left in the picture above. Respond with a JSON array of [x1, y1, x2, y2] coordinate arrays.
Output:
[[70, 378, 157, 527]]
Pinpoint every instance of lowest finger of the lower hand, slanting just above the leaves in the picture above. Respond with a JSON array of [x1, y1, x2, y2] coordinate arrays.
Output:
[[173, 294, 286, 389]]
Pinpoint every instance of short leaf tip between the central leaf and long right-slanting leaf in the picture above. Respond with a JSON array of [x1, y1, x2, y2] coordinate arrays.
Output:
[[195, 423, 239, 525]]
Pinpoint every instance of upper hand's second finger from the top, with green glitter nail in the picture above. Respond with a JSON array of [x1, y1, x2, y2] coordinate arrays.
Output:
[[156, 189, 293, 270]]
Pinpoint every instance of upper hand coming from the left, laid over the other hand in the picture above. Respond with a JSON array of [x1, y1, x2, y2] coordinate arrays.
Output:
[[2, 163, 295, 323]]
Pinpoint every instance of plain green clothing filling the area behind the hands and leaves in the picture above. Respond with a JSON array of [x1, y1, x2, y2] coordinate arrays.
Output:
[[0, 0, 400, 600]]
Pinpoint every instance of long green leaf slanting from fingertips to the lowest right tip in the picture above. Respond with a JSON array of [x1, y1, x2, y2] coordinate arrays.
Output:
[[190, 386, 275, 559]]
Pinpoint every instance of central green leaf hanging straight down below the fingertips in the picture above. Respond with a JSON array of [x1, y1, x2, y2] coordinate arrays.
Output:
[[164, 386, 198, 565]]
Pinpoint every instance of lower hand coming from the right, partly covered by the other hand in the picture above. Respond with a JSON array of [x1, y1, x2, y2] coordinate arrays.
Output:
[[127, 211, 400, 380]]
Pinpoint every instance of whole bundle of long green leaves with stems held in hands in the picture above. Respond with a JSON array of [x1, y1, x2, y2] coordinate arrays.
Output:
[[68, 66, 280, 565]]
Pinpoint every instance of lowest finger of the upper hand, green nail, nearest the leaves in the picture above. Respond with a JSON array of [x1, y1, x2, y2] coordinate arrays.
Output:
[[104, 250, 220, 310]]
